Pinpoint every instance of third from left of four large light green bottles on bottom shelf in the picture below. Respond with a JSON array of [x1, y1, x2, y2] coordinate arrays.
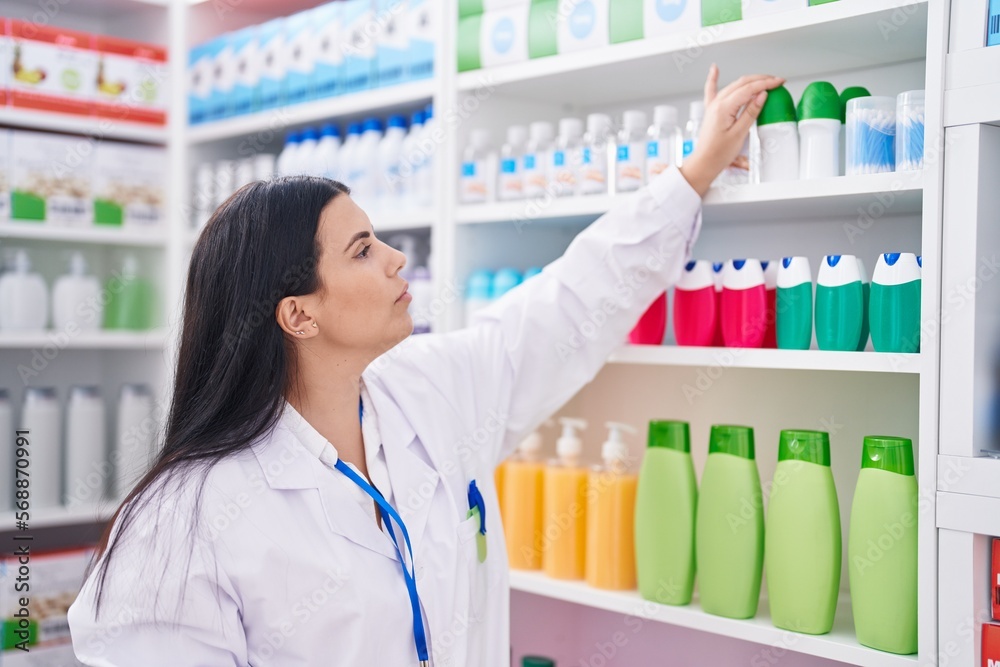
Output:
[[764, 431, 841, 635]]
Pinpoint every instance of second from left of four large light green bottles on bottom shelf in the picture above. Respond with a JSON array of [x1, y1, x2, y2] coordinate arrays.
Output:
[[695, 426, 764, 618]]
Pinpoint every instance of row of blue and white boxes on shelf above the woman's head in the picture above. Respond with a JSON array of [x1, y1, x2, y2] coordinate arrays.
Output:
[[188, 0, 439, 125]]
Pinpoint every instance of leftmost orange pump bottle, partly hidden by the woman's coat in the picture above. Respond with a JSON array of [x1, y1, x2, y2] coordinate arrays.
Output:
[[500, 431, 545, 570]]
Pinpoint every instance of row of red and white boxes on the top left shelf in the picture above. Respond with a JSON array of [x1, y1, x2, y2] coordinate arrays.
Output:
[[0, 17, 169, 125]]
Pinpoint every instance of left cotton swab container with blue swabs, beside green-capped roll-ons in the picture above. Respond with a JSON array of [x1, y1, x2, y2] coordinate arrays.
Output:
[[846, 96, 896, 176]]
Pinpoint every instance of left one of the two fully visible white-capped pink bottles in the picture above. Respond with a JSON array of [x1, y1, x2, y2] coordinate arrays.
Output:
[[674, 259, 721, 346]]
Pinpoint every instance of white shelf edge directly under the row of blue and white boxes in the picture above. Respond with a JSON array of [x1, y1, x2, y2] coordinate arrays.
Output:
[[187, 79, 436, 144]]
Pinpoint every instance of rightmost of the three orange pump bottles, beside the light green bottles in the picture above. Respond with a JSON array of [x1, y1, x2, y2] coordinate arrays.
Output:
[[587, 422, 637, 590]]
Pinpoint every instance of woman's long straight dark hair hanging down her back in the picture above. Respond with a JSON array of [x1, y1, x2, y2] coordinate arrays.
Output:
[[95, 176, 350, 611]]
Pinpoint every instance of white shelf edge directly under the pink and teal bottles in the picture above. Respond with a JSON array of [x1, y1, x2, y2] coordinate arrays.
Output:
[[608, 345, 920, 374]]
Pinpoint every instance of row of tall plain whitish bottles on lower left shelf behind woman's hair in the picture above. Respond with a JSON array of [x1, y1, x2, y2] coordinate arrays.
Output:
[[0, 384, 157, 512]]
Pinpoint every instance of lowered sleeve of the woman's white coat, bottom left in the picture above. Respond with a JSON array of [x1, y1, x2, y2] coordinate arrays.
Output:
[[68, 486, 246, 667]]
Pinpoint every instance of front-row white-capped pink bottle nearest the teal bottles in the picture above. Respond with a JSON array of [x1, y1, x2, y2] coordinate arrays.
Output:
[[720, 259, 767, 347]]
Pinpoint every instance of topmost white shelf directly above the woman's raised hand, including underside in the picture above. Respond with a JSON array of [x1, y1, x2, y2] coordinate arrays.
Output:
[[457, 0, 927, 106]]
